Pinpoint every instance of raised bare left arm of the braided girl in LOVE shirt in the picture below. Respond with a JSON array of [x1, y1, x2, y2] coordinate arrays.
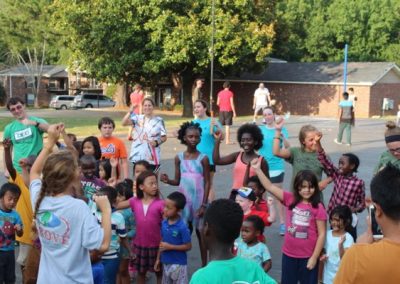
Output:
[[29, 123, 64, 181]]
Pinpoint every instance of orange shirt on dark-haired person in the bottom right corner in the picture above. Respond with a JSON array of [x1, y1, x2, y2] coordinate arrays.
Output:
[[334, 239, 400, 284]]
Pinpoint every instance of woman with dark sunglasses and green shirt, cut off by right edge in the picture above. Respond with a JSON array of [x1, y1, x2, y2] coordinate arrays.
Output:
[[374, 121, 400, 174]]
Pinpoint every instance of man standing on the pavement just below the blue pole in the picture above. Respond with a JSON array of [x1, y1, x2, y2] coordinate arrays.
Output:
[[334, 92, 354, 146]]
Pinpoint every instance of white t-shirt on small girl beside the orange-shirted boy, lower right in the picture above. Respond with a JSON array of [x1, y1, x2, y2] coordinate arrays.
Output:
[[323, 230, 354, 284]]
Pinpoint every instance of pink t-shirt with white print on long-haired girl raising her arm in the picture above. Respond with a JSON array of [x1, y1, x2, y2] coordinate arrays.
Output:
[[282, 191, 327, 258]]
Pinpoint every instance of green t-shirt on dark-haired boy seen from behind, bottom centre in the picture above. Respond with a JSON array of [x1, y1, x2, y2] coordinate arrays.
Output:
[[190, 256, 277, 284]]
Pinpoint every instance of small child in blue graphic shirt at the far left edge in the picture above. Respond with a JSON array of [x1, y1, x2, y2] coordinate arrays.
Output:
[[0, 182, 23, 283]]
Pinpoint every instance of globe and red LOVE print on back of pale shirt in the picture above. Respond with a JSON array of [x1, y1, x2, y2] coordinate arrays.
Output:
[[37, 211, 71, 247]]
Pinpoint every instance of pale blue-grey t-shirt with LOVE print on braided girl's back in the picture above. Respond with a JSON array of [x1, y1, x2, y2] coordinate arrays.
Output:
[[29, 179, 104, 284]]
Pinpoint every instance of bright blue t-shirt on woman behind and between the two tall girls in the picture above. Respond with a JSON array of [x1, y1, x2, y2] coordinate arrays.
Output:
[[193, 117, 222, 165]]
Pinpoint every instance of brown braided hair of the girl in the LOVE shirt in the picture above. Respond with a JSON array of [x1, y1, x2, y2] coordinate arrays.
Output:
[[33, 151, 79, 231]]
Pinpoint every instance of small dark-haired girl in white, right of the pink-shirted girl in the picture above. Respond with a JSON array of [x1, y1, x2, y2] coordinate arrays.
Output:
[[320, 205, 354, 284]]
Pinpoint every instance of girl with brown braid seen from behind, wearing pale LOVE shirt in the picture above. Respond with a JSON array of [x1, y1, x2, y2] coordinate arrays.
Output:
[[29, 124, 111, 283]]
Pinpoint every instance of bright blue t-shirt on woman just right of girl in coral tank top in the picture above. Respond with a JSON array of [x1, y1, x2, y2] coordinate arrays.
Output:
[[258, 125, 289, 174]]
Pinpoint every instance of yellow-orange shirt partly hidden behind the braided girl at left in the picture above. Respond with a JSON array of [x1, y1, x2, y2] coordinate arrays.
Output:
[[10, 172, 33, 245]]
